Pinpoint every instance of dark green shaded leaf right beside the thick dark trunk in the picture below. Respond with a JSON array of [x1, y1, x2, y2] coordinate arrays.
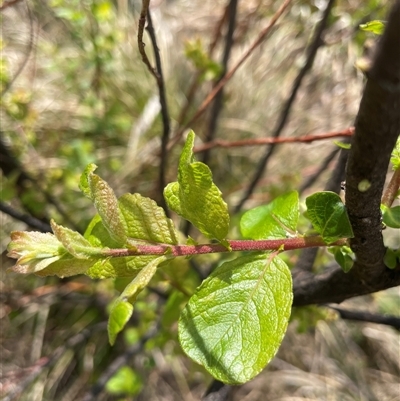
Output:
[[306, 191, 354, 244]]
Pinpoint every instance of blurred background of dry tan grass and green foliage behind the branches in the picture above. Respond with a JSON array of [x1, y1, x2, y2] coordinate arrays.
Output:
[[0, 0, 400, 401]]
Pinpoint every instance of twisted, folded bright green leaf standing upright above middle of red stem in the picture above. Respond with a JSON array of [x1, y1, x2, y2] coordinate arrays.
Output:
[[164, 131, 229, 245]]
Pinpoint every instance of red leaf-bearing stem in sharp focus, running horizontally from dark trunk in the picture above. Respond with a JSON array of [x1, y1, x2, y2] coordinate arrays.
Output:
[[102, 236, 347, 257]]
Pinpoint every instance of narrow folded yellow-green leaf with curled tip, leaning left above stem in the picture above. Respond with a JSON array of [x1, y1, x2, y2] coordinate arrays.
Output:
[[79, 164, 126, 245]]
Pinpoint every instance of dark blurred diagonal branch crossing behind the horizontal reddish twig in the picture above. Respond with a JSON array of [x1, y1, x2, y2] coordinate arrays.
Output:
[[235, 0, 335, 212]]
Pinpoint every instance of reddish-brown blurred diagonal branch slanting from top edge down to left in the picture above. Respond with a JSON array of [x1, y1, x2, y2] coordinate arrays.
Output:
[[169, 0, 292, 147]]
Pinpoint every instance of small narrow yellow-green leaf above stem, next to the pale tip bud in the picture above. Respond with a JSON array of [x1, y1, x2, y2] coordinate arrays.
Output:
[[50, 220, 103, 259]]
